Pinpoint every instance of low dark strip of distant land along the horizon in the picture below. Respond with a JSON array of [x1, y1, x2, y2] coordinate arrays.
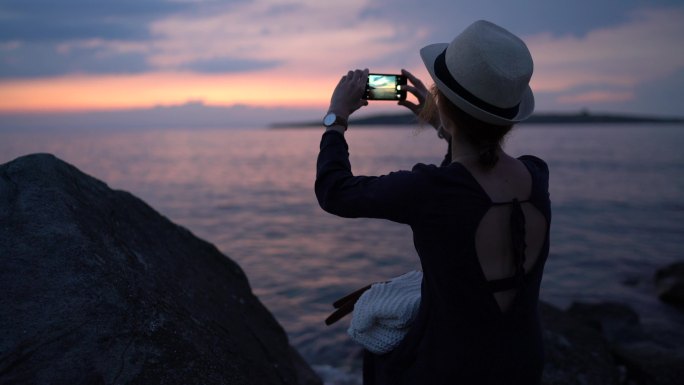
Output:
[[270, 111, 684, 128]]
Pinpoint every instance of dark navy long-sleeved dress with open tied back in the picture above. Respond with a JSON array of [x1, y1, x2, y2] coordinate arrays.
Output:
[[315, 131, 551, 385]]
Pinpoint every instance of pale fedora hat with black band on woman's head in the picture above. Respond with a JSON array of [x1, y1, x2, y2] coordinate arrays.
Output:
[[420, 20, 534, 125]]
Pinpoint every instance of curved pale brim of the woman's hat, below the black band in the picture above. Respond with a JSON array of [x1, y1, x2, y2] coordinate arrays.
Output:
[[420, 43, 534, 126]]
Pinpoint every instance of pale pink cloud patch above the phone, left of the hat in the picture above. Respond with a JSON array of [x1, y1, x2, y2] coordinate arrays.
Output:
[[148, 0, 427, 76]]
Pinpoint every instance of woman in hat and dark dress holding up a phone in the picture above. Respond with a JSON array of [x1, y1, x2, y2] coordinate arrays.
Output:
[[316, 21, 551, 385]]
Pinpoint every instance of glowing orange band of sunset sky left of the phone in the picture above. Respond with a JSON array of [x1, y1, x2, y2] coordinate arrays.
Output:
[[0, 72, 337, 113]]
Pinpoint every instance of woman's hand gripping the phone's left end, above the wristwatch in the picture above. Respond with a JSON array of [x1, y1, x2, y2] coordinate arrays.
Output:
[[328, 69, 368, 119]]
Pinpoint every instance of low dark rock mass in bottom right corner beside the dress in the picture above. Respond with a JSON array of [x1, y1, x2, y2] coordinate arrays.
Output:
[[542, 302, 684, 385]]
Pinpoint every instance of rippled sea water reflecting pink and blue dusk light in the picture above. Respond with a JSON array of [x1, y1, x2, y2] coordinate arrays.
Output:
[[0, 124, 684, 384]]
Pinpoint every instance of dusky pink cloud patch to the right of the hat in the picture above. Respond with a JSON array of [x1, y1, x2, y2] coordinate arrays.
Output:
[[525, 7, 684, 93]]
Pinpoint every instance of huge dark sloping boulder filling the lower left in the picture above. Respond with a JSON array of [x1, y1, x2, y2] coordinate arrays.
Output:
[[0, 155, 320, 385]]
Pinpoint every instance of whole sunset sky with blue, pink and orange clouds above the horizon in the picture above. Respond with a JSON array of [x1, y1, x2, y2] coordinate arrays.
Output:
[[0, 0, 684, 126]]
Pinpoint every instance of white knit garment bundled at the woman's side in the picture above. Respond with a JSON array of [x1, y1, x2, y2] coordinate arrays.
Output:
[[347, 271, 423, 354]]
